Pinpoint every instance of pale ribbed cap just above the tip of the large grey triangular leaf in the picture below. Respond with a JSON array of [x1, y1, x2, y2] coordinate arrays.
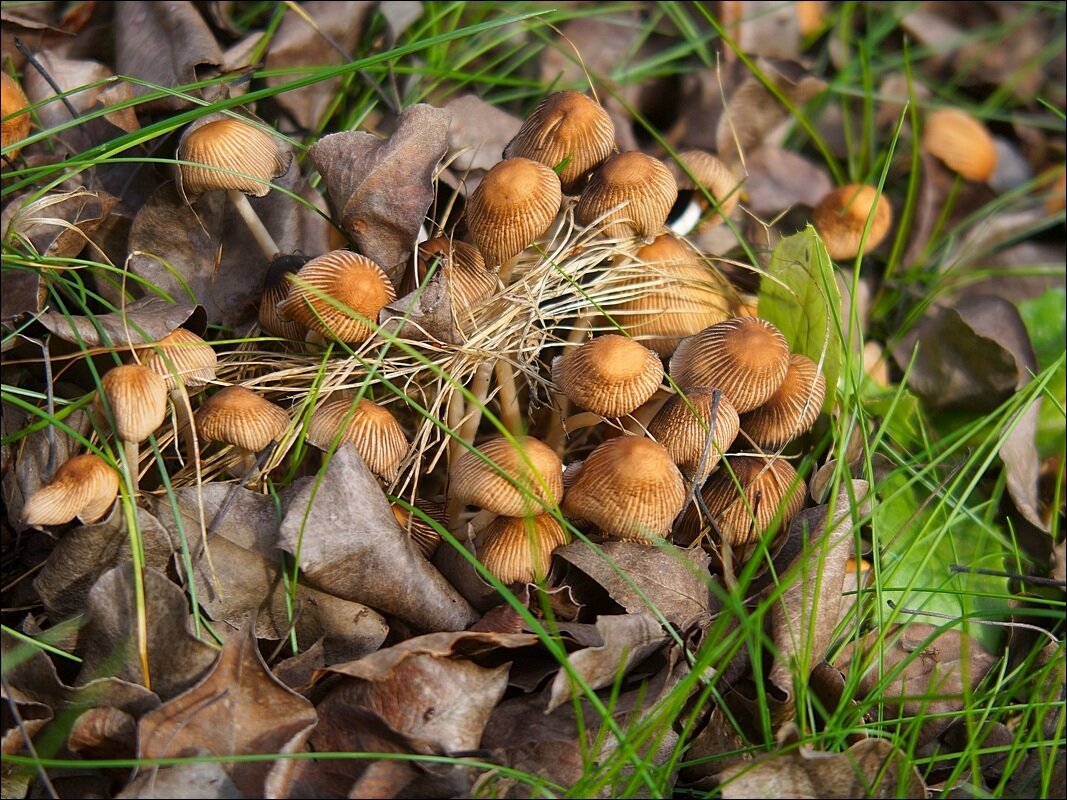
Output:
[[307, 391, 408, 481]]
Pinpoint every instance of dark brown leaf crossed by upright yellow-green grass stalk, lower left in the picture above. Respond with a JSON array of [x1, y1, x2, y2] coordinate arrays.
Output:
[[78, 562, 216, 700]]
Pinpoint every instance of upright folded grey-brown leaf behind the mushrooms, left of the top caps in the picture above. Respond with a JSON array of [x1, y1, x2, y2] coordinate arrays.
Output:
[[309, 103, 451, 284]]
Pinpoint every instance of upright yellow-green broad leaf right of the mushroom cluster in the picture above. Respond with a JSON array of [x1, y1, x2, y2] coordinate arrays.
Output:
[[760, 225, 844, 413]]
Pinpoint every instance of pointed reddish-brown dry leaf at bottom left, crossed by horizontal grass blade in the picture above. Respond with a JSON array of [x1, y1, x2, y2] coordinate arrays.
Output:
[[138, 628, 318, 797]]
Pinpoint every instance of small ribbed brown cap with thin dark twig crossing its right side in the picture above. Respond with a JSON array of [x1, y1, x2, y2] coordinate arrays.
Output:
[[648, 386, 738, 483]]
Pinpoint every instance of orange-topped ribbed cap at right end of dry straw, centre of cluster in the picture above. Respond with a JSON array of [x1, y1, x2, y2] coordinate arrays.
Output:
[[552, 334, 664, 418]]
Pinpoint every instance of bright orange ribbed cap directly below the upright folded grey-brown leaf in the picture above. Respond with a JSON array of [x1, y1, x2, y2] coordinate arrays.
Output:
[[277, 250, 397, 345]]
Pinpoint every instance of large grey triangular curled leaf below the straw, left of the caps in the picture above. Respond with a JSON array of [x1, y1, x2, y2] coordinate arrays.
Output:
[[278, 444, 478, 630]]
